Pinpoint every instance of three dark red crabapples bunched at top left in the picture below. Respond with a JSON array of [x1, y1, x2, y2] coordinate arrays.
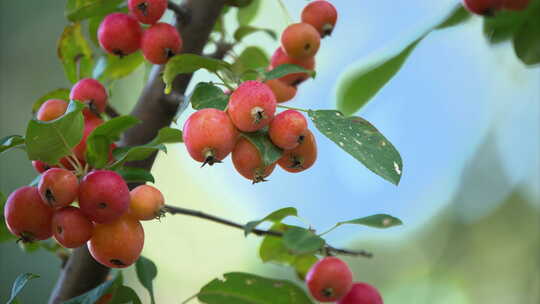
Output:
[[98, 0, 182, 64]]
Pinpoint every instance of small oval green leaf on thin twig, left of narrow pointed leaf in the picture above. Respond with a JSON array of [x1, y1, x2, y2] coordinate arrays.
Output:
[[283, 226, 326, 254]]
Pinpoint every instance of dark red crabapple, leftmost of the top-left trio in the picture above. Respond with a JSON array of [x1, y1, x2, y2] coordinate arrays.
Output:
[[98, 13, 142, 57]]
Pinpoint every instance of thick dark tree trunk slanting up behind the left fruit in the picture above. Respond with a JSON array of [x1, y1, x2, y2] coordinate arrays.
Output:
[[49, 0, 224, 304]]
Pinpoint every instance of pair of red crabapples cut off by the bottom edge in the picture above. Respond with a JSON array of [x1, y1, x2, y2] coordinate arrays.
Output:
[[306, 257, 383, 304]]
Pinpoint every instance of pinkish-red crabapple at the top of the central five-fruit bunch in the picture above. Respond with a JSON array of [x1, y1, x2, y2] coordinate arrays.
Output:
[[227, 80, 276, 132]]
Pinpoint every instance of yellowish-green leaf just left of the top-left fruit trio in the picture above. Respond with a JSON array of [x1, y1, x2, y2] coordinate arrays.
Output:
[[58, 23, 94, 83]]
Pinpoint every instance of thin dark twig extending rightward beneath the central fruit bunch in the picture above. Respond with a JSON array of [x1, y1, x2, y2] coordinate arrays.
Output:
[[164, 205, 373, 258]]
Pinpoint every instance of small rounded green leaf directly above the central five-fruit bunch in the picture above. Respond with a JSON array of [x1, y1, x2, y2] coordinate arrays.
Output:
[[232, 46, 270, 81]]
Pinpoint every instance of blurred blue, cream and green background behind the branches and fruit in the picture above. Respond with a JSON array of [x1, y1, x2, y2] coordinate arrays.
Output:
[[0, 0, 540, 304]]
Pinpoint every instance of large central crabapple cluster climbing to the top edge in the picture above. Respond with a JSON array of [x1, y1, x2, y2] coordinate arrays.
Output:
[[183, 0, 337, 183]]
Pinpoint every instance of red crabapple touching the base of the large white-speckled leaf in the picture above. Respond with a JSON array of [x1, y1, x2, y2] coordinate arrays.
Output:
[[268, 110, 307, 150]]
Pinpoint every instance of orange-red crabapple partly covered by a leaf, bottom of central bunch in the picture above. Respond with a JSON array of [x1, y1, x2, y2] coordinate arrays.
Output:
[[232, 137, 276, 184]]
